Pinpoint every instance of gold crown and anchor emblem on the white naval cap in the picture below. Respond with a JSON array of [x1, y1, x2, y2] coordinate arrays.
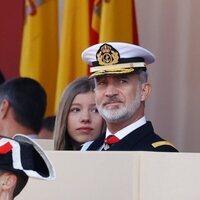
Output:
[[96, 44, 119, 65]]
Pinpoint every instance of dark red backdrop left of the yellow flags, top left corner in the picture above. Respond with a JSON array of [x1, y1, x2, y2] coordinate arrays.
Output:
[[0, 0, 24, 79]]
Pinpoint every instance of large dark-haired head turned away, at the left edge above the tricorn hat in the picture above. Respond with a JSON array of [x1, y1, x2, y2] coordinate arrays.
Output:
[[0, 78, 47, 138]]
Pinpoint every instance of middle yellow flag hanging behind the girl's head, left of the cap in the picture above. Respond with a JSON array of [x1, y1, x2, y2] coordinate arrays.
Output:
[[56, 0, 89, 107]]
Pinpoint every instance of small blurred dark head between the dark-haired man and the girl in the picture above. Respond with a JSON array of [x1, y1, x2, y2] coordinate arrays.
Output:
[[38, 115, 56, 139]]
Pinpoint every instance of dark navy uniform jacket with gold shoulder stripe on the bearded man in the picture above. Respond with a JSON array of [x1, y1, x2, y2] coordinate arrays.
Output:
[[87, 121, 178, 152]]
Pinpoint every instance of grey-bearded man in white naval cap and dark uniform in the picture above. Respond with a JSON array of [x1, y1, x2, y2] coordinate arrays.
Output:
[[82, 42, 177, 152]]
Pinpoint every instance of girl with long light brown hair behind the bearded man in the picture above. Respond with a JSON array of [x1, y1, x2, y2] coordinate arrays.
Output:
[[54, 77, 105, 150]]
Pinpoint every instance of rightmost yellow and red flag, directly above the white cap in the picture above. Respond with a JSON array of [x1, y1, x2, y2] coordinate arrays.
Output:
[[90, 0, 138, 44]]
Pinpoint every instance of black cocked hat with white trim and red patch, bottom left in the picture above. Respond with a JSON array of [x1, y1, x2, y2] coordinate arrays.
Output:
[[0, 134, 56, 180]]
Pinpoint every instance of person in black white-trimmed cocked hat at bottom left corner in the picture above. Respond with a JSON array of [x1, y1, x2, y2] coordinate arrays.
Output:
[[0, 134, 56, 200]]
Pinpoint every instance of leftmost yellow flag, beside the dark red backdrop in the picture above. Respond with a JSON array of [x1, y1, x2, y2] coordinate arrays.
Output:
[[20, 0, 58, 115]]
